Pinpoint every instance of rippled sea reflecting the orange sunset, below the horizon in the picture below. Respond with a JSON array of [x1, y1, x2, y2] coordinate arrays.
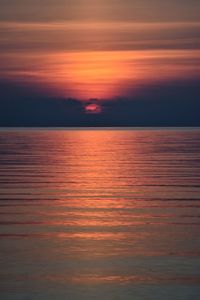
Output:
[[0, 129, 200, 300]]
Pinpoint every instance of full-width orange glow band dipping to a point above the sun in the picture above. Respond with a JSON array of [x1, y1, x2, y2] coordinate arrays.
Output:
[[0, 49, 200, 100]]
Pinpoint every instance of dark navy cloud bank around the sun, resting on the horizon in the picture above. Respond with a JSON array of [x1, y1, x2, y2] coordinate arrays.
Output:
[[0, 79, 200, 127]]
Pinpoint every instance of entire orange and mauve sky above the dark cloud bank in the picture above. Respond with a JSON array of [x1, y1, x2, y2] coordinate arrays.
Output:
[[0, 0, 200, 100]]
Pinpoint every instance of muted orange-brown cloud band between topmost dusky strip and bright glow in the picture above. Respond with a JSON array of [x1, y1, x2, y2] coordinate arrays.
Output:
[[0, 21, 200, 52]]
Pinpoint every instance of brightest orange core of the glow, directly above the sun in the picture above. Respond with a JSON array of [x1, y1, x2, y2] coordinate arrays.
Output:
[[56, 51, 133, 99]]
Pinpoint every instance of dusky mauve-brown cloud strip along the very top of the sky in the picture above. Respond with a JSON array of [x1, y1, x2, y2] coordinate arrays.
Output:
[[0, 0, 200, 22]]
